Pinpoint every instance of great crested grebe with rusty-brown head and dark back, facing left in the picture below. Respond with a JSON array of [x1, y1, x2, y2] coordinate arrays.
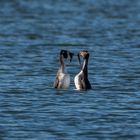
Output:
[[74, 50, 91, 90]]
